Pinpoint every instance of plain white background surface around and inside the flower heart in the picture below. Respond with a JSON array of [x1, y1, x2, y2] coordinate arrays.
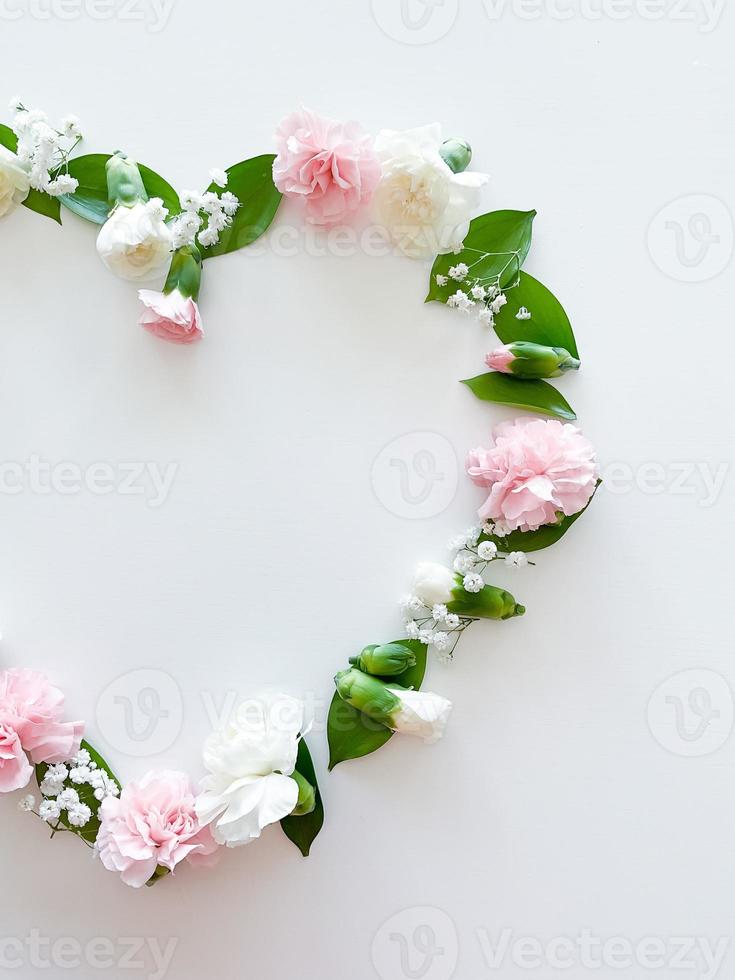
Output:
[[0, 0, 735, 980]]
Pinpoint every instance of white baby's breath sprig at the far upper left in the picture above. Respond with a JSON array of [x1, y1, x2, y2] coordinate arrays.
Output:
[[10, 99, 82, 197]]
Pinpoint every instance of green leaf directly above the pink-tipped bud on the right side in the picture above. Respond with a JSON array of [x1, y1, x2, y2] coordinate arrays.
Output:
[[495, 272, 579, 358]]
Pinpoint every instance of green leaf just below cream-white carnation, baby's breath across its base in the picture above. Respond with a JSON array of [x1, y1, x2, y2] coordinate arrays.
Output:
[[425, 211, 536, 303]]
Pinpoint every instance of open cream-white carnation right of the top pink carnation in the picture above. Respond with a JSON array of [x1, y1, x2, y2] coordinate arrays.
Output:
[[375, 123, 488, 259]]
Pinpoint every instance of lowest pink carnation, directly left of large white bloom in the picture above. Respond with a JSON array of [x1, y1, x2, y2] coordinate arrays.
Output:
[[96, 770, 217, 888]]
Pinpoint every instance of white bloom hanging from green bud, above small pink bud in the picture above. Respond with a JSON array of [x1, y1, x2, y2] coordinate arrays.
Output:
[[97, 201, 171, 282]]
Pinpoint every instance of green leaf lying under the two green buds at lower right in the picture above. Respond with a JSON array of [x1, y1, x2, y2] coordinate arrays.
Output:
[[327, 640, 426, 771]]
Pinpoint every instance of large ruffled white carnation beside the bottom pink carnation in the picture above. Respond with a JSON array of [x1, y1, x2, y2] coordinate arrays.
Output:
[[196, 694, 304, 847]]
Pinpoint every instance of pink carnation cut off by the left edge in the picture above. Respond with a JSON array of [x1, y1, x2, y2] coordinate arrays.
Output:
[[0, 668, 84, 793]]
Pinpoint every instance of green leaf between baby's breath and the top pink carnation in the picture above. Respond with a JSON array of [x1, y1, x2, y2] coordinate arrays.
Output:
[[201, 153, 281, 259]]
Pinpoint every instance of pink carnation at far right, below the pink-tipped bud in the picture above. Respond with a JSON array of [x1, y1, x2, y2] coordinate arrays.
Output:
[[467, 419, 597, 531]]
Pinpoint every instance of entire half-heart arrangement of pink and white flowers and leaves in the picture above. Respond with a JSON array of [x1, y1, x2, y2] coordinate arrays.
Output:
[[0, 99, 599, 888]]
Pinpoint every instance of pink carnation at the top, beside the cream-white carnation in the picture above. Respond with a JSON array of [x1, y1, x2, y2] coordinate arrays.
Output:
[[273, 109, 381, 225]]
